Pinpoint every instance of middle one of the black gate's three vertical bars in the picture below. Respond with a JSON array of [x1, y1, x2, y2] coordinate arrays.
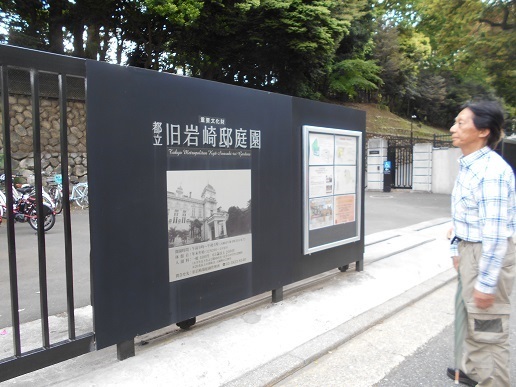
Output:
[[30, 69, 50, 348]]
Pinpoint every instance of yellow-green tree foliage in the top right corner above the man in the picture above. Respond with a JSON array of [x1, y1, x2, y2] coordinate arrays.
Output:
[[418, 0, 516, 106]]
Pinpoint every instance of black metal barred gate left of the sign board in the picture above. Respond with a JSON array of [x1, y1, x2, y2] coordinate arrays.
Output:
[[0, 46, 94, 382]]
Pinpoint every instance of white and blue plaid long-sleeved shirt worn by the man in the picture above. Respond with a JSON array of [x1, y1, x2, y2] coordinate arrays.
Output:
[[451, 147, 516, 294]]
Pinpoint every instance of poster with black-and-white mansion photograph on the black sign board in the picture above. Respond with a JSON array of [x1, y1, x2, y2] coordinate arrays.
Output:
[[167, 169, 252, 282]]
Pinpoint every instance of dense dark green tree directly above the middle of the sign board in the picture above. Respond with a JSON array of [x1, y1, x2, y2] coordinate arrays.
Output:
[[178, 0, 352, 97]]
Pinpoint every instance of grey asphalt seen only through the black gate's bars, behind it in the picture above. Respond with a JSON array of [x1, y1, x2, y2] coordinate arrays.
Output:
[[0, 210, 90, 328]]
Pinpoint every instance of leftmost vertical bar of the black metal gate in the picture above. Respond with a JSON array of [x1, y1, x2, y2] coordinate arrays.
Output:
[[1, 66, 21, 357]]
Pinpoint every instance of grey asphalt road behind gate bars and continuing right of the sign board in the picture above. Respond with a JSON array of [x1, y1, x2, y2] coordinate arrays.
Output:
[[0, 190, 450, 328]]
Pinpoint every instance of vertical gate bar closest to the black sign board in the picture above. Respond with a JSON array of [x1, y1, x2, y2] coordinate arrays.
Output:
[[58, 74, 75, 340]]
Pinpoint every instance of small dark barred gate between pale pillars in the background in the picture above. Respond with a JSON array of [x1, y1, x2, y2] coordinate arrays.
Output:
[[387, 140, 413, 189]]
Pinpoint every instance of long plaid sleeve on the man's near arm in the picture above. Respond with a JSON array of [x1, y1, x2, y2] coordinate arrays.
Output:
[[475, 174, 509, 294]]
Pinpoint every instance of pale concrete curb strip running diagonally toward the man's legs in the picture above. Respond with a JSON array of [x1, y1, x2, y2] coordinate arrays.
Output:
[[224, 268, 456, 387]]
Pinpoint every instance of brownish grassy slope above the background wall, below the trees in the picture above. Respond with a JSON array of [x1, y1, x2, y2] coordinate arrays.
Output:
[[345, 103, 449, 138]]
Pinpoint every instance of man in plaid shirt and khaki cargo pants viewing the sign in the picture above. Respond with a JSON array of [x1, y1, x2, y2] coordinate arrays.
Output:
[[447, 101, 516, 387]]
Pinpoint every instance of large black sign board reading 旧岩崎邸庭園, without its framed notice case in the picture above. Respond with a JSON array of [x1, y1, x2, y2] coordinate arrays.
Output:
[[87, 61, 365, 349]]
